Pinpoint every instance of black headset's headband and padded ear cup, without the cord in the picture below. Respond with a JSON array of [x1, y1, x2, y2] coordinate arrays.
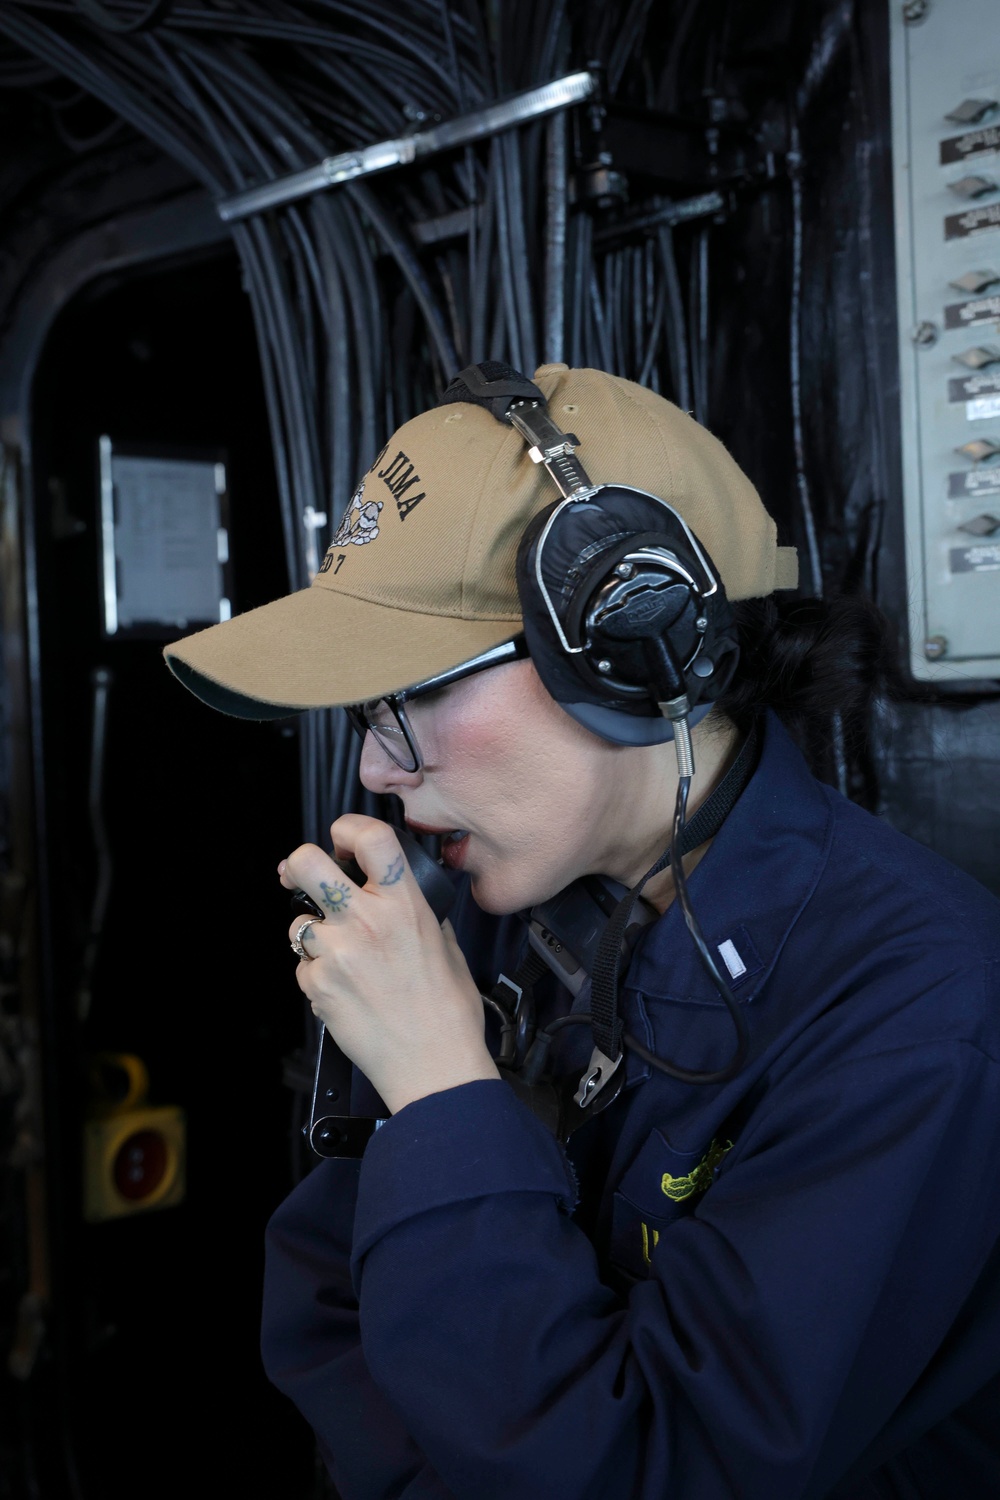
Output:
[[441, 360, 739, 746]]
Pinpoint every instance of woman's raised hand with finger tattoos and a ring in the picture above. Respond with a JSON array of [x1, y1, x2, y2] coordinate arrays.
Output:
[[279, 813, 499, 1115]]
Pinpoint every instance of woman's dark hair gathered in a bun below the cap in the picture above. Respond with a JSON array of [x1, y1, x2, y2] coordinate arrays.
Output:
[[718, 594, 903, 801]]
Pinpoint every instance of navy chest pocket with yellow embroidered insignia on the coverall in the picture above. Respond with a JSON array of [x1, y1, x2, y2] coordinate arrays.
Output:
[[610, 1131, 733, 1281]]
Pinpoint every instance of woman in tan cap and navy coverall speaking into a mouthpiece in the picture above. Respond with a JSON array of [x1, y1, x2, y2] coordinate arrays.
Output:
[[168, 366, 1000, 1500]]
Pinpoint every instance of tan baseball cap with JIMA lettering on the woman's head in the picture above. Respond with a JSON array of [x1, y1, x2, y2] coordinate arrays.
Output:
[[163, 365, 798, 719]]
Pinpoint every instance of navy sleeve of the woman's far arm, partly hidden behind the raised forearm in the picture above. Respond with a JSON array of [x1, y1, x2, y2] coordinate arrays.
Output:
[[261, 1161, 451, 1500]]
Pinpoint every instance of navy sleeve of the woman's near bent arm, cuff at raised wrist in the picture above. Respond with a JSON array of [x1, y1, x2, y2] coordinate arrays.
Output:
[[347, 1040, 1000, 1500]]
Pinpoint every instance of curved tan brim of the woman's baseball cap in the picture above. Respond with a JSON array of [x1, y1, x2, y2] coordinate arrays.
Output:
[[163, 588, 522, 719]]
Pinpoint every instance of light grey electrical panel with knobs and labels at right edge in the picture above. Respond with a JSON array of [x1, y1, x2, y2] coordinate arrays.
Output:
[[891, 0, 1000, 681]]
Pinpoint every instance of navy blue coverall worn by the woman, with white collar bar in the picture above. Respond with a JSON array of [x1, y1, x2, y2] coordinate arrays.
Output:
[[262, 717, 1000, 1500]]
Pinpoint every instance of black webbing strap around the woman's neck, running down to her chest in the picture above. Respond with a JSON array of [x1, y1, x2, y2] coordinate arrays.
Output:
[[591, 725, 757, 1061]]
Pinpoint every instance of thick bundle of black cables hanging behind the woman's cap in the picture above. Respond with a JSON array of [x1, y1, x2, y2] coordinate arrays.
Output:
[[0, 0, 728, 837]]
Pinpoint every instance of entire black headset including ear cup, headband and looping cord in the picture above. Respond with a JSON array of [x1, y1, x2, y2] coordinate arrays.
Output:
[[439, 360, 756, 1130]]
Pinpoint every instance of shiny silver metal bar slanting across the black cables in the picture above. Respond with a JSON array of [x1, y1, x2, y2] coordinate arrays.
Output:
[[216, 72, 598, 224]]
